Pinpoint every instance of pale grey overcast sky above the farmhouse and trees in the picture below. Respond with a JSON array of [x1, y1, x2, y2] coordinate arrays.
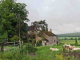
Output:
[[17, 0, 80, 34]]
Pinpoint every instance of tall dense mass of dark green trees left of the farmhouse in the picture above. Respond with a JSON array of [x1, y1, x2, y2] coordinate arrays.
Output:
[[0, 0, 29, 38]]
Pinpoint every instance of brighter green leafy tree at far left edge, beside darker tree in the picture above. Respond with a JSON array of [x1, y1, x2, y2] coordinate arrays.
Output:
[[0, 0, 15, 38]]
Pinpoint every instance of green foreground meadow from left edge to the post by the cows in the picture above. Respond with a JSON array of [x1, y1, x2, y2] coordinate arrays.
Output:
[[0, 44, 63, 60]]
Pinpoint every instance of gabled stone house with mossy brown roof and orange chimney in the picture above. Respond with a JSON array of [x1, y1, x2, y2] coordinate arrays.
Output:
[[42, 29, 60, 46]]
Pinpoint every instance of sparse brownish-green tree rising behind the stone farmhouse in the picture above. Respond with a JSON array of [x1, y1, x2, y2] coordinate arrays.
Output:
[[31, 20, 48, 38]]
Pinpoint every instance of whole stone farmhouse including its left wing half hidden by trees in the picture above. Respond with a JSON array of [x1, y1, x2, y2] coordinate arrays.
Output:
[[28, 27, 60, 46]]
